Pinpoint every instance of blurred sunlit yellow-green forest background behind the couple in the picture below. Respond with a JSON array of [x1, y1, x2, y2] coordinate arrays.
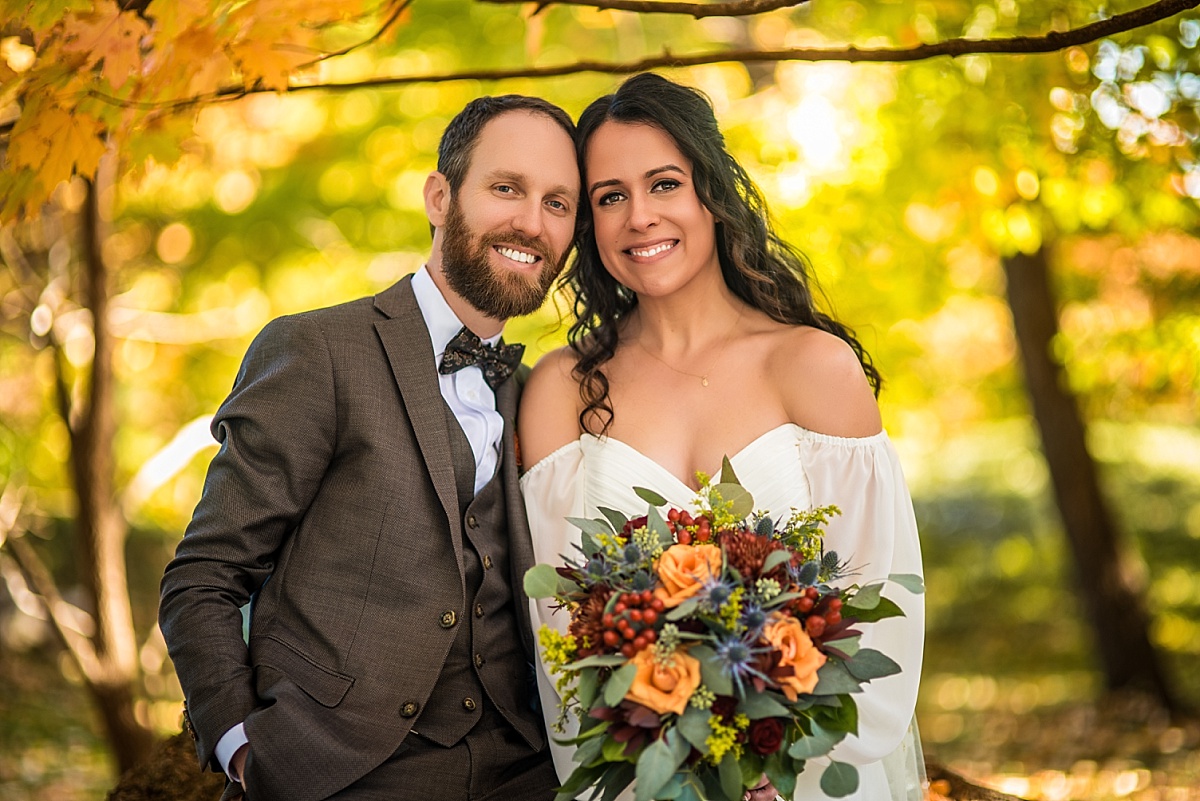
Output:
[[0, 0, 1200, 801]]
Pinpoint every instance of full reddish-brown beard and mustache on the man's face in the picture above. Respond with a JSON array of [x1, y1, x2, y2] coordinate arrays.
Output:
[[442, 201, 566, 320]]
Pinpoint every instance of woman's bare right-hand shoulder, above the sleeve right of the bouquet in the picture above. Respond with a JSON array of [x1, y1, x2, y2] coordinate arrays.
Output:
[[770, 325, 882, 436]]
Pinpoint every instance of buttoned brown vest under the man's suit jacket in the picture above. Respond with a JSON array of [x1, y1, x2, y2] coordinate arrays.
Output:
[[413, 406, 545, 749]]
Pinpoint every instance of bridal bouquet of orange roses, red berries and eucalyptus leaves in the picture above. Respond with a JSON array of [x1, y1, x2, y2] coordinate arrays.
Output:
[[524, 460, 923, 801]]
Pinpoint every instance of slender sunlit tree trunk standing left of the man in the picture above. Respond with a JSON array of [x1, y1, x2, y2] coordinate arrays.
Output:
[[67, 168, 155, 772]]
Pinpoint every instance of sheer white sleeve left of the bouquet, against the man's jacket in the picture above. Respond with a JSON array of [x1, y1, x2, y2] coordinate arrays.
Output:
[[521, 440, 584, 782]]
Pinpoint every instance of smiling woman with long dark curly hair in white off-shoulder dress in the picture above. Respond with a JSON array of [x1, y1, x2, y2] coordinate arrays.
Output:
[[520, 74, 924, 801]]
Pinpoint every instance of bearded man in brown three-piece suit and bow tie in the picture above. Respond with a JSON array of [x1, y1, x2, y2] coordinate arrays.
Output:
[[160, 95, 580, 801]]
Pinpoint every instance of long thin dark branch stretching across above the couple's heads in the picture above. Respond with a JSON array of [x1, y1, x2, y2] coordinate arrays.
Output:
[[72, 0, 1200, 113]]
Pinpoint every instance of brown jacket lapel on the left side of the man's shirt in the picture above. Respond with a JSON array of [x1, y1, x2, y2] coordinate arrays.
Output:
[[374, 277, 462, 582]]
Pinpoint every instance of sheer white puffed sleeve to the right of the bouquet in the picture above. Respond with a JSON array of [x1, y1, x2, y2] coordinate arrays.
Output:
[[799, 432, 925, 765]]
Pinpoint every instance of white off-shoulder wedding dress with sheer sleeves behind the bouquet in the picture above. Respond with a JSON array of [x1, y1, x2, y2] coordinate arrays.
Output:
[[521, 423, 925, 801]]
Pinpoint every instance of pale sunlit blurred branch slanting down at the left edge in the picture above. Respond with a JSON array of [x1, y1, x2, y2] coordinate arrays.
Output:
[[0, 483, 101, 681]]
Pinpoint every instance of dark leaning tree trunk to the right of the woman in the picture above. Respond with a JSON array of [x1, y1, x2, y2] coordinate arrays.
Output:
[[1003, 249, 1177, 710]]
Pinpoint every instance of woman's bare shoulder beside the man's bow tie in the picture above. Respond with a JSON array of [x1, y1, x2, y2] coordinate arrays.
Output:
[[517, 348, 581, 464]]
